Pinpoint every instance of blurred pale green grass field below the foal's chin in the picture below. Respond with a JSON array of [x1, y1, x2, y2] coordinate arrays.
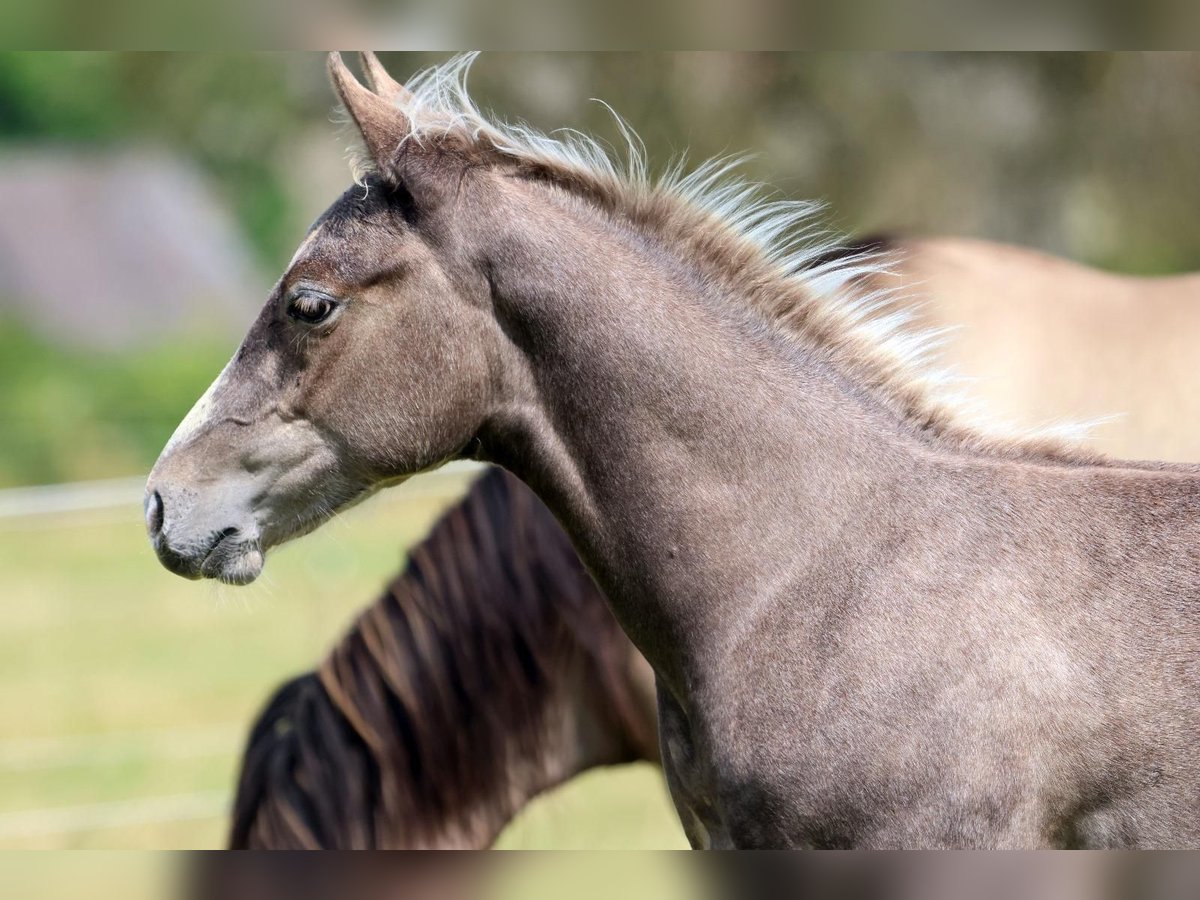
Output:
[[0, 474, 683, 848]]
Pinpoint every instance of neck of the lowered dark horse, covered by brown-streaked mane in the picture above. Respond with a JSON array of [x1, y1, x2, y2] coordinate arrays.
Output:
[[322, 472, 634, 848]]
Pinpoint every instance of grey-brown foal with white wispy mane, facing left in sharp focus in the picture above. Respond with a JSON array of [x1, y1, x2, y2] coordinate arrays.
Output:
[[146, 55, 1200, 847]]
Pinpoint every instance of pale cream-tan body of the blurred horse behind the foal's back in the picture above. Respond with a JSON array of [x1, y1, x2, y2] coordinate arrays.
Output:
[[878, 238, 1200, 461]]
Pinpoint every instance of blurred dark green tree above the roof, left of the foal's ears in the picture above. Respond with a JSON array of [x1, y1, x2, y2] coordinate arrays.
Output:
[[0, 53, 329, 269]]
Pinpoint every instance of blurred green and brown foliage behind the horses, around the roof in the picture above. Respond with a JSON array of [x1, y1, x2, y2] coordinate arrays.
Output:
[[0, 53, 1200, 485]]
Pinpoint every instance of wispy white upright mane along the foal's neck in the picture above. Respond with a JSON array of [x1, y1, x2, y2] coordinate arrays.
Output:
[[364, 53, 1094, 454]]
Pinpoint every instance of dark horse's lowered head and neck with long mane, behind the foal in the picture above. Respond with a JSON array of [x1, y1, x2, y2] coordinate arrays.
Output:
[[229, 469, 658, 848]]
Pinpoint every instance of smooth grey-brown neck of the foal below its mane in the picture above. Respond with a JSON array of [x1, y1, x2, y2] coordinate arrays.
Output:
[[472, 190, 914, 684]]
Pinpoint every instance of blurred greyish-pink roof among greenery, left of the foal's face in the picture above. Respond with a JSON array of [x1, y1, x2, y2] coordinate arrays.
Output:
[[0, 149, 263, 347]]
